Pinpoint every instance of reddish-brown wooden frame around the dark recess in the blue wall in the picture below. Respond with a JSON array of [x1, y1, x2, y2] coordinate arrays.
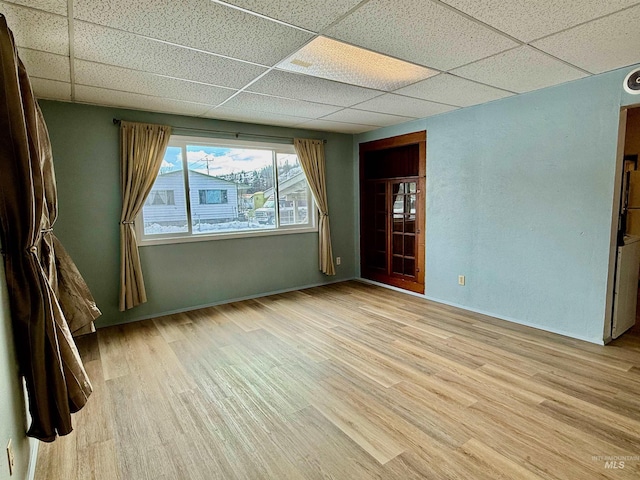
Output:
[[359, 130, 427, 294]]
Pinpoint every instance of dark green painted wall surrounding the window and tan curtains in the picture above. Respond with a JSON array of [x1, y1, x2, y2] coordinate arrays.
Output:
[[40, 101, 356, 326]]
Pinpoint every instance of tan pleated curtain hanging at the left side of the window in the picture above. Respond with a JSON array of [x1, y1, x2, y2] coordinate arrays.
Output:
[[120, 122, 171, 311]]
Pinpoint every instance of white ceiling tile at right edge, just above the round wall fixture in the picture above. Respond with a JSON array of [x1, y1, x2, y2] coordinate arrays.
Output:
[[533, 5, 640, 73]]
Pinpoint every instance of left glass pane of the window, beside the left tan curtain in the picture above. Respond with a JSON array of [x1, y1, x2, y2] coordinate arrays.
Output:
[[142, 147, 189, 235]]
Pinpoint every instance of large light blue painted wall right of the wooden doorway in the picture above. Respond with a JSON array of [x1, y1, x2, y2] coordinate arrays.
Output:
[[354, 67, 640, 343]]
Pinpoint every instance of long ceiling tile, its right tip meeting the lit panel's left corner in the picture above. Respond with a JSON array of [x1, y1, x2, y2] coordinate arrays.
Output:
[[75, 21, 267, 88]]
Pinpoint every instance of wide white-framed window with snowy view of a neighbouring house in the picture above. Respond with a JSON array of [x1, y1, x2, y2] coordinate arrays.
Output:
[[136, 135, 316, 245]]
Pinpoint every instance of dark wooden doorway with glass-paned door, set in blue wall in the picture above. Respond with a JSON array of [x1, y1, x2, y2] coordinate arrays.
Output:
[[360, 132, 425, 293]]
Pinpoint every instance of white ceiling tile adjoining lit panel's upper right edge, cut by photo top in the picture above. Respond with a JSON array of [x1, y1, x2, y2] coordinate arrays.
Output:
[[325, 0, 517, 70]]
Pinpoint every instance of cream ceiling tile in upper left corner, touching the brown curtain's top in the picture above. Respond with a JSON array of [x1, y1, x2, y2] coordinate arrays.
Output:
[[0, 2, 69, 55]]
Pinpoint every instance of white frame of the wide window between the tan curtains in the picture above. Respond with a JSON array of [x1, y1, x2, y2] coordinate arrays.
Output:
[[135, 135, 318, 247]]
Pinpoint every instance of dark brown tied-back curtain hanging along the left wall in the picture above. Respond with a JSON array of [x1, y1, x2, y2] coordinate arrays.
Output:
[[0, 15, 100, 441]]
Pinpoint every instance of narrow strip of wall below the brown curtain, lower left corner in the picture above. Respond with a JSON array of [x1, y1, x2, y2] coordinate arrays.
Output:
[[0, 237, 30, 480]]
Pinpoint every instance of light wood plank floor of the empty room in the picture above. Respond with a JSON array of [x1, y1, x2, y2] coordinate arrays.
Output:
[[36, 282, 640, 480]]
